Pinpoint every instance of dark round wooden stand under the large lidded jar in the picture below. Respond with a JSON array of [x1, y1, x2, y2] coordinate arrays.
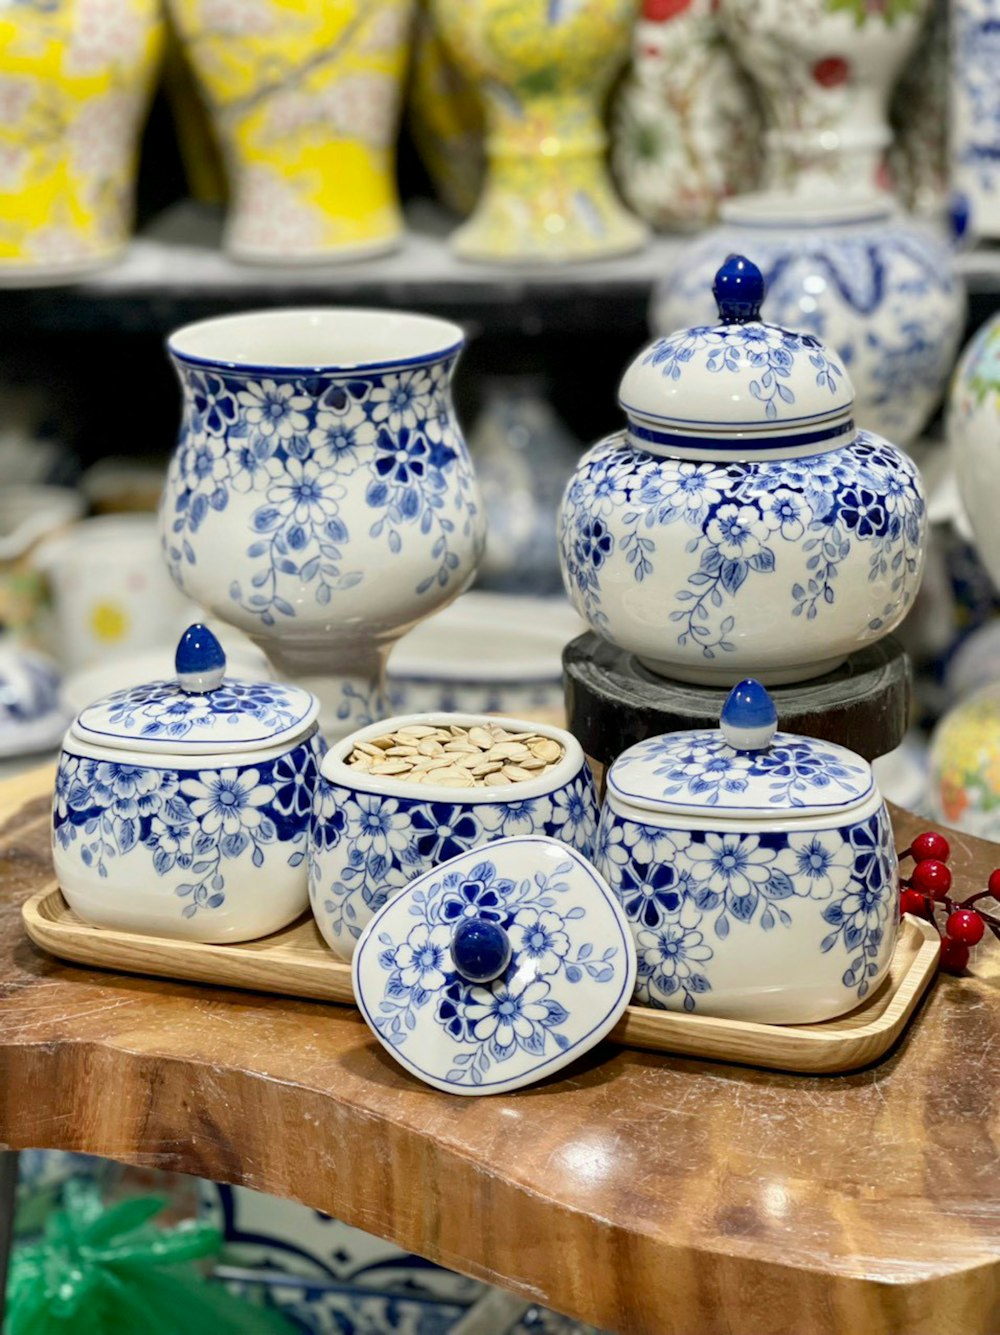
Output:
[[562, 634, 911, 765]]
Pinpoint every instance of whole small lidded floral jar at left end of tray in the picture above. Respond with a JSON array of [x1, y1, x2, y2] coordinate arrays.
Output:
[[52, 626, 324, 943]]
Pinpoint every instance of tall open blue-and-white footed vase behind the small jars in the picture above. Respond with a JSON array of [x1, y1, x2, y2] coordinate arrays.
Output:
[[160, 308, 485, 738]]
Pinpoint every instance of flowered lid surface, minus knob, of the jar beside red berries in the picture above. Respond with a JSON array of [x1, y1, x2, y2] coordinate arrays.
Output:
[[609, 729, 873, 812]]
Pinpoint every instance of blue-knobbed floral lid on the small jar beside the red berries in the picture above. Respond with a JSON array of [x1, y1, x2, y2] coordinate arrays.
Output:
[[607, 677, 876, 821]]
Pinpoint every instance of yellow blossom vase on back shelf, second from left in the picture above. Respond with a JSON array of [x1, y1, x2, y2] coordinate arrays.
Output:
[[170, 0, 414, 264]]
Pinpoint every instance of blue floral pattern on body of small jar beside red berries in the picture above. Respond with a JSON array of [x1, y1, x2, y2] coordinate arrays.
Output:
[[597, 806, 899, 1011]]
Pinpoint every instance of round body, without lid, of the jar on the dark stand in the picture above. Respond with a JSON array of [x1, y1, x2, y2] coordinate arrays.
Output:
[[561, 431, 927, 686]]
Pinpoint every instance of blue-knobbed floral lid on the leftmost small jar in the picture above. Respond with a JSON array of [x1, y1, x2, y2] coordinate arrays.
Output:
[[71, 623, 319, 756]]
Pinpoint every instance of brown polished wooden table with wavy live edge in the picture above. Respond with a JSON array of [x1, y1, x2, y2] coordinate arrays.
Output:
[[0, 772, 1000, 1335]]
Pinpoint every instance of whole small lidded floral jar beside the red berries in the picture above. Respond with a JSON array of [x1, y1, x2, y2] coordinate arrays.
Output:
[[597, 681, 899, 1024]]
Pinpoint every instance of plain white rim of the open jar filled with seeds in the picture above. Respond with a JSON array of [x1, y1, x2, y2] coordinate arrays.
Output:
[[319, 709, 586, 806]]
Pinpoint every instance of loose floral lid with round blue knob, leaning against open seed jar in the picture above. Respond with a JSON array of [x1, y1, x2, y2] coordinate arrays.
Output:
[[352, 837, 636, 1095]]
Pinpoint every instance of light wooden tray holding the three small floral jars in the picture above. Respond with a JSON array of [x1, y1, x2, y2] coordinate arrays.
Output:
[[21, 881, 940, 1075]]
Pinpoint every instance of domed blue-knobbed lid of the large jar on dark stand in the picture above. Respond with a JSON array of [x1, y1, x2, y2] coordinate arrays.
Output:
[[618, 255, 854, 459]]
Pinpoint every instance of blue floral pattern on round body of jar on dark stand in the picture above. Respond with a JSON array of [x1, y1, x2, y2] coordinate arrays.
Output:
[[561, 431, 925, 659]]
